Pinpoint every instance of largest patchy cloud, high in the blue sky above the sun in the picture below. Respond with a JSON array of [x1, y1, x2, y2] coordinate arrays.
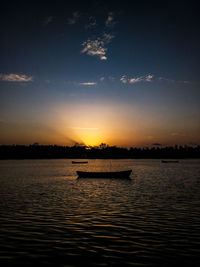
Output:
[[81, 33, 114, 60]]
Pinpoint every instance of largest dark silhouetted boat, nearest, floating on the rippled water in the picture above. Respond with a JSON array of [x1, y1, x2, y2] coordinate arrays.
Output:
[[77, 170, 132, 178]]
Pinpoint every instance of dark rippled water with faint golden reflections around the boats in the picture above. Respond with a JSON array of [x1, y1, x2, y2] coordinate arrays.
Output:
[[0, 159, 200, 266]]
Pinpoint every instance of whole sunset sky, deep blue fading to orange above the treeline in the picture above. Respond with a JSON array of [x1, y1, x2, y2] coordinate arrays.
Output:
[[0, 0, 200, 147]]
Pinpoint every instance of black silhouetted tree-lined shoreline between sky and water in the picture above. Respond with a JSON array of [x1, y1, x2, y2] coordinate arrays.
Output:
[[0, 145, 200, 160]]
